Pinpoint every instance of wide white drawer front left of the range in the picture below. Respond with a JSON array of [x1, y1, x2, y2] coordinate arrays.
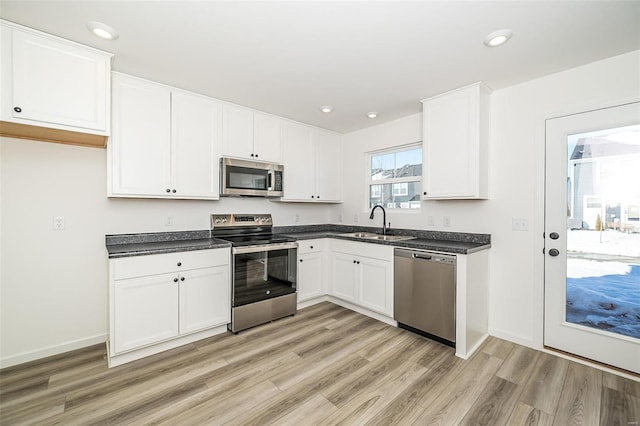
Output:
[[112, 248, 231, 280]]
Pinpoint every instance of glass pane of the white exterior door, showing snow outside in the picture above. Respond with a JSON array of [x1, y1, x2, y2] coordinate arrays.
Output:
[[566, 125, 640, 338]]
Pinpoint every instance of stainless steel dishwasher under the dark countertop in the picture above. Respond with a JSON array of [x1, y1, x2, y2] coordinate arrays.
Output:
[[393, 248, 456, 347]]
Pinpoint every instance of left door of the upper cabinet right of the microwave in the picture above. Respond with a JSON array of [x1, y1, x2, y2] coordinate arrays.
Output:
[[283, 122, 316, 201]]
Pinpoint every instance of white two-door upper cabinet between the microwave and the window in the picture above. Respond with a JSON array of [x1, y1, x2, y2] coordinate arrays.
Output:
[[282, 122, 342, 203]]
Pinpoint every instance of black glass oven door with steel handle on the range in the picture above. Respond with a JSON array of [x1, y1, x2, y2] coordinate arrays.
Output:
[[231, 242, 298, 308]]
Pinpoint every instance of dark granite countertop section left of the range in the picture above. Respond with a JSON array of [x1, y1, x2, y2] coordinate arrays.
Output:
[[105, 231, 231, 259]]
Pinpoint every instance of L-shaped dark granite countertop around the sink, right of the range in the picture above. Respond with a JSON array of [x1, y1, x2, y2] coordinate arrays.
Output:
[[274, 225, 491, 254]]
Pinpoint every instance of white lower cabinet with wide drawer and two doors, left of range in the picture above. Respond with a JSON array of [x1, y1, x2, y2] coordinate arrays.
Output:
[[109, 248, 231, 366]]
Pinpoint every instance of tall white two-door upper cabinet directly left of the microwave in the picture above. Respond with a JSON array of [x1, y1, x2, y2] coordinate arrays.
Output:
[[107, 73, 220, 199]]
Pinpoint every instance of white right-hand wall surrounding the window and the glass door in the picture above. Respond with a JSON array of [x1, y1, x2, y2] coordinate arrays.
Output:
[[340, 51, 640, 348]]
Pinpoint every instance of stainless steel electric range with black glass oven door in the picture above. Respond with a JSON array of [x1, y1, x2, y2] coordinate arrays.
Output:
[[211, 214, 298, 333]]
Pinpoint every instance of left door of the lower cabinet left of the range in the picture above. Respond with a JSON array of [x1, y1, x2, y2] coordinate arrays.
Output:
[[112, 274, 178, 353]]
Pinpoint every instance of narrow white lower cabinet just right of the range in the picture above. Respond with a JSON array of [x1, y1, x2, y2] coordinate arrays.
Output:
[[297, 240, 327, 302]]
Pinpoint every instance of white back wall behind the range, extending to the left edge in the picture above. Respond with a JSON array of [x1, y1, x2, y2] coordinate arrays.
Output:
[[0, 138, 329, 366]]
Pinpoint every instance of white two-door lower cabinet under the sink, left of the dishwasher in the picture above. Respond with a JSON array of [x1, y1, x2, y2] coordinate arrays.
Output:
[[329, 240, 393, 317]]
